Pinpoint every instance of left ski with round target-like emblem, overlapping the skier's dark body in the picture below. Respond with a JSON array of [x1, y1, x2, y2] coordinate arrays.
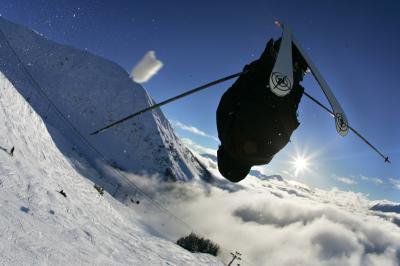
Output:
[[269, 21, 293, 97]]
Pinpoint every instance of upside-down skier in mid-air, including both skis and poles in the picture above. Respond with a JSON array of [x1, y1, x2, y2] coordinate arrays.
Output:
[[91, 21, 390, 182]]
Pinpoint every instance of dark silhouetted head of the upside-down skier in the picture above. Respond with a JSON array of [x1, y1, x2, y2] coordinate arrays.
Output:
[[217, 146, 251, 182]]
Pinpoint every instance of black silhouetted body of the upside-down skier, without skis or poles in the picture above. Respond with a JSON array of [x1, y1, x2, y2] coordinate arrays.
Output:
[[217, 39, 308, 182]]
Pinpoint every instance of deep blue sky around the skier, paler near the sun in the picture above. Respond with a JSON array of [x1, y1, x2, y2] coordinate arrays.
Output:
[[0, 0, 400, 201]]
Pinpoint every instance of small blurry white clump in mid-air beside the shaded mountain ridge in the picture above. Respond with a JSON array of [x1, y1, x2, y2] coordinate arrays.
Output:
[[131, 51, 163, 83]]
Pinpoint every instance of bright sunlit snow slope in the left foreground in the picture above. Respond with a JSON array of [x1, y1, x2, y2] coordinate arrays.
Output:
[[0, 70, 222, 265]]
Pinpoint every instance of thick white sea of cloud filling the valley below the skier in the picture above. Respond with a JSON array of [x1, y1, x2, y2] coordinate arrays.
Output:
[[124, 163, 400, 265]]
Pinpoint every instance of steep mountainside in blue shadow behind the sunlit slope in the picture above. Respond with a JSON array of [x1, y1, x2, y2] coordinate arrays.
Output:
[[0, 18, 209, 183]]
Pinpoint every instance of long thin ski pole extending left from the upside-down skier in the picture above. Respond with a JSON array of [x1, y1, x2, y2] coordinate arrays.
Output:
[[90, 71, 247, 135]]
